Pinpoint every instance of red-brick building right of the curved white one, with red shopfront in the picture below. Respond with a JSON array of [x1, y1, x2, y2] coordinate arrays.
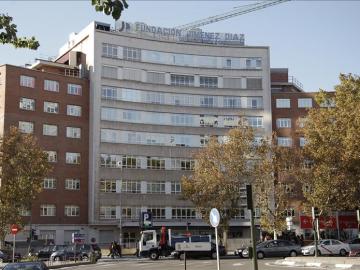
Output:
[[271, 69, 358, 238]]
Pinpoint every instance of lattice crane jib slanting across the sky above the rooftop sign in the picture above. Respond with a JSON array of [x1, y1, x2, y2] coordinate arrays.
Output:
[[175, 0, 290, 30]]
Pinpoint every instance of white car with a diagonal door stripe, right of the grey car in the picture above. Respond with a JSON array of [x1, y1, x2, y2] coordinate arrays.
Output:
[[301, 239, 350, 256]]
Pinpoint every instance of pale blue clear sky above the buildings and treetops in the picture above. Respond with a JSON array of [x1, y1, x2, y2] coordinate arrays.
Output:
[[0, 0, 360, 91]]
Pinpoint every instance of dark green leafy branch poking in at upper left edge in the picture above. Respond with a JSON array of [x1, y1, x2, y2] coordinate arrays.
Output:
[[0, 14, 40, 50]]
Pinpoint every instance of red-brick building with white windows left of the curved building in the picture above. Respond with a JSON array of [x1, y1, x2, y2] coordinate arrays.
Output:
[[0, 60, 89, 242]]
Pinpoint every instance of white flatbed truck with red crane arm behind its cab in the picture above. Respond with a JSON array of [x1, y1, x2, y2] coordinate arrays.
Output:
[[139, 227, 216, 260]]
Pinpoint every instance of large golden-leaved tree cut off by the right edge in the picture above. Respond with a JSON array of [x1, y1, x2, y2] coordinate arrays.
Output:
[[303, 74, 360, 212]]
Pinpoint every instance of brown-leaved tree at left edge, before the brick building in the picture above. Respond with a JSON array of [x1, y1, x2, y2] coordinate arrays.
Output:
[[0, 127, 50, 247]]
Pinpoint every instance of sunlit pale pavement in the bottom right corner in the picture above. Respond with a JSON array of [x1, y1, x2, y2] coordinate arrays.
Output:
[[275, 256, 360, 270]]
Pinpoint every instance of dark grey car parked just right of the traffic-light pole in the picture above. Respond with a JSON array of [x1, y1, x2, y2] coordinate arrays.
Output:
[[242, 240, 301, 259]]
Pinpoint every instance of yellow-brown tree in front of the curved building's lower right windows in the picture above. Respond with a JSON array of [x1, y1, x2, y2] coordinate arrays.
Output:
[[182, 127, 257, 245]]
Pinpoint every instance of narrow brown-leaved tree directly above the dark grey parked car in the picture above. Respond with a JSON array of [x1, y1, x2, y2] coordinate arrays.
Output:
[[254, 141, 302, 239]]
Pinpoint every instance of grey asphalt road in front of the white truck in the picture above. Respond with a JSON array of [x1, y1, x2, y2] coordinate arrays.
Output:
[[62, 259, 320, 270]]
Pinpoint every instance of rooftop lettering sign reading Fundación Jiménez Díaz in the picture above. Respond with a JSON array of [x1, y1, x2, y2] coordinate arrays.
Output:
[[115, 21, 245, 46]]
